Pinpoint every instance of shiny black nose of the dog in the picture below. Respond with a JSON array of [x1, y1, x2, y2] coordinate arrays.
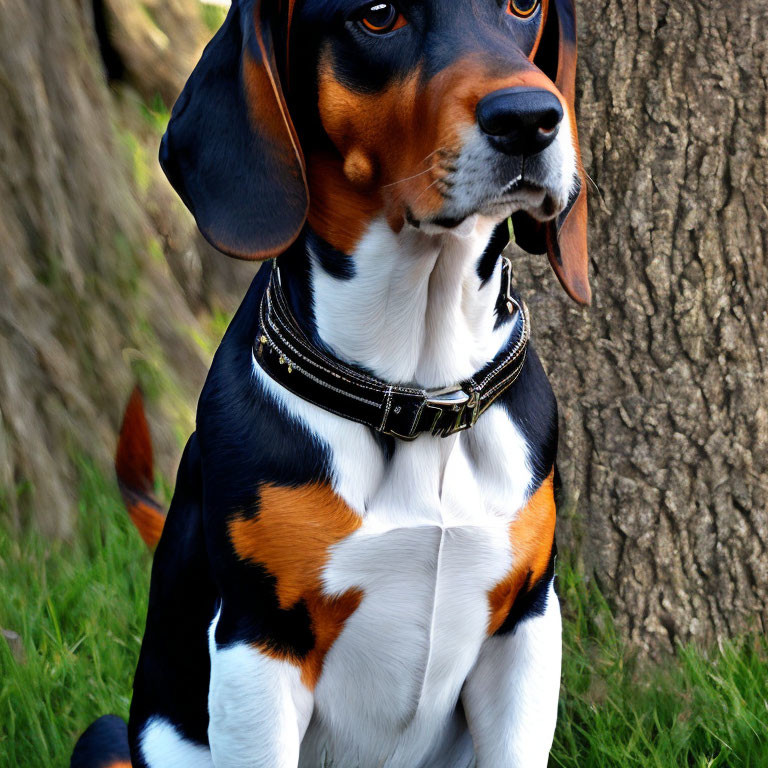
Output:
[[477, 87, 563, 155]]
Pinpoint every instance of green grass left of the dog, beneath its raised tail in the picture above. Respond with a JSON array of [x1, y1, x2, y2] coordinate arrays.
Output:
[[0, 465, 151, 768]]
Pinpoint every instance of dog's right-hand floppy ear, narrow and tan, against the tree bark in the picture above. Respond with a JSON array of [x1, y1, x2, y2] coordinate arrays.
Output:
[[512, 0, 592, 304]]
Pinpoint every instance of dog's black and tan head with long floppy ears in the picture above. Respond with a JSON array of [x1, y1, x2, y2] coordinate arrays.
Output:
[[161, 0, 590, 303]]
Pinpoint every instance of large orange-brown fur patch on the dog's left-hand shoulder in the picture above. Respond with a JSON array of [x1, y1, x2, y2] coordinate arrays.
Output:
[[228, 483, 363, 689]]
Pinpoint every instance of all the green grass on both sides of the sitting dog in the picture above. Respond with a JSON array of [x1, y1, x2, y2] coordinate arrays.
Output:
[[0, 464, 768, 768]]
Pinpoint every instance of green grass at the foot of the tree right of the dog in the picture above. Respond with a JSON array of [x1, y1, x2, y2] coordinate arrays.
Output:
[[550, 568, 768, 768]]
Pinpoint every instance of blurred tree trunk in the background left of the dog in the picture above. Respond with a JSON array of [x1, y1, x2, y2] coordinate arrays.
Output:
[[0, 0, 253, 535]]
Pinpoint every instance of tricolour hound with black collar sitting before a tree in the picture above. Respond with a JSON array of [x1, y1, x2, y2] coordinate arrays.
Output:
[[73, 0, 590, 768]]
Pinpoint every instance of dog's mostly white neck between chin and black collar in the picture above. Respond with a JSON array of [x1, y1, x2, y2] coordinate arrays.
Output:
[[280, 214, 510, 388]]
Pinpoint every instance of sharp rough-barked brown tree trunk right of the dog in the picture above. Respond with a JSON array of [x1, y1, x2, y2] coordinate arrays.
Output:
[[516, 0, 768, 652]]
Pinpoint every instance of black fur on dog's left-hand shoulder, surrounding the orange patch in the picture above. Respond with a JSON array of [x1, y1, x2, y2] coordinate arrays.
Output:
[[198, 268, 329, 658]]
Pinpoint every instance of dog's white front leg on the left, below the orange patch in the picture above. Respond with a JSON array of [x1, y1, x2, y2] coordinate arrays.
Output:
[[208, 643, 313, 768]]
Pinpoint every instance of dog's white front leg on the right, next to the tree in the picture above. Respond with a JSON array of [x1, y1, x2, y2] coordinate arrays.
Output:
[[462, 584, 562, 768]]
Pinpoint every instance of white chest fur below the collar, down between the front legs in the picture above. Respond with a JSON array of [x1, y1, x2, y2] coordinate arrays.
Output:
[[304, 423, 530, 766]]
